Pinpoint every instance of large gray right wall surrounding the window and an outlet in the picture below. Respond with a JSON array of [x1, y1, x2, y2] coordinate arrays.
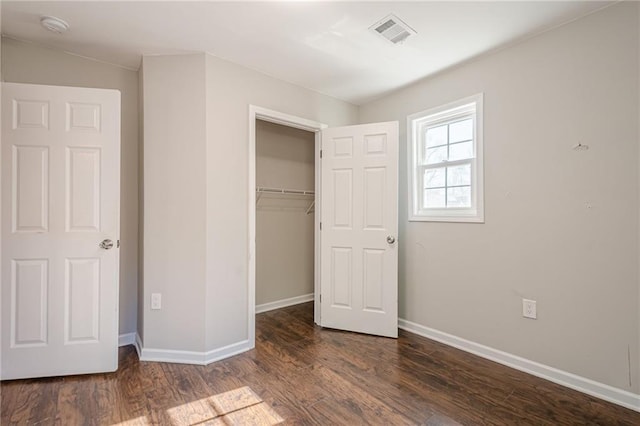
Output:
[[360, 3, 640, 393]]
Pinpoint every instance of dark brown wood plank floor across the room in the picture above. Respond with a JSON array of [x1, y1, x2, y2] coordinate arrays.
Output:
[[0, 303, 640, 426]]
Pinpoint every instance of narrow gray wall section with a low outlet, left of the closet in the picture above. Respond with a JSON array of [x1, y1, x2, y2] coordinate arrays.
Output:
[[142, 54, 208, 352]]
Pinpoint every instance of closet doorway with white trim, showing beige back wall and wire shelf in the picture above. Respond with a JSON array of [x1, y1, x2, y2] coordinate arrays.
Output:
[[248, 106, 327, 342]]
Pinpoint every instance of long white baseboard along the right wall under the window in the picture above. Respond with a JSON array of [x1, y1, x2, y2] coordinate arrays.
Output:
[[398, 319, 640, 412]]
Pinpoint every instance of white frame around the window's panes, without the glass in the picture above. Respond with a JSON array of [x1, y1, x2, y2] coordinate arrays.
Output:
[[407, 93, 484, 223]]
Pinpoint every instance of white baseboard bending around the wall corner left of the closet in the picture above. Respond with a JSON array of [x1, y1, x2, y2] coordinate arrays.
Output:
[[136, 337, 253, 365]]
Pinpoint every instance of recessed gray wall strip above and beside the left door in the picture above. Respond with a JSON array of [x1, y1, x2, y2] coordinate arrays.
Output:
[[2, 37, 138, 334]]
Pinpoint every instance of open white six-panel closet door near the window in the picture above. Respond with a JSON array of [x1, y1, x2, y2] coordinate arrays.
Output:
[[320, 122, 398, 337]]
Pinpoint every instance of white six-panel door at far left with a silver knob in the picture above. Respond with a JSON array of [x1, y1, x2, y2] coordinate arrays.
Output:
[[0, 83, 120, 379]]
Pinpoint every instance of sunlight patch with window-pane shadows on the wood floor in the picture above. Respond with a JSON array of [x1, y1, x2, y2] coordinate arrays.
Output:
[[167, 386, 284, 426]]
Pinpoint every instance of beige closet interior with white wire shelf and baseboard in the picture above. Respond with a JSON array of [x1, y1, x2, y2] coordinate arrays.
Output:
[[255, 120, 315, 313]]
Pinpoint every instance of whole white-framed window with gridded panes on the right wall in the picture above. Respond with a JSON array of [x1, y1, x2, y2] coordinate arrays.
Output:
[[407, 94, 484, 222]]
